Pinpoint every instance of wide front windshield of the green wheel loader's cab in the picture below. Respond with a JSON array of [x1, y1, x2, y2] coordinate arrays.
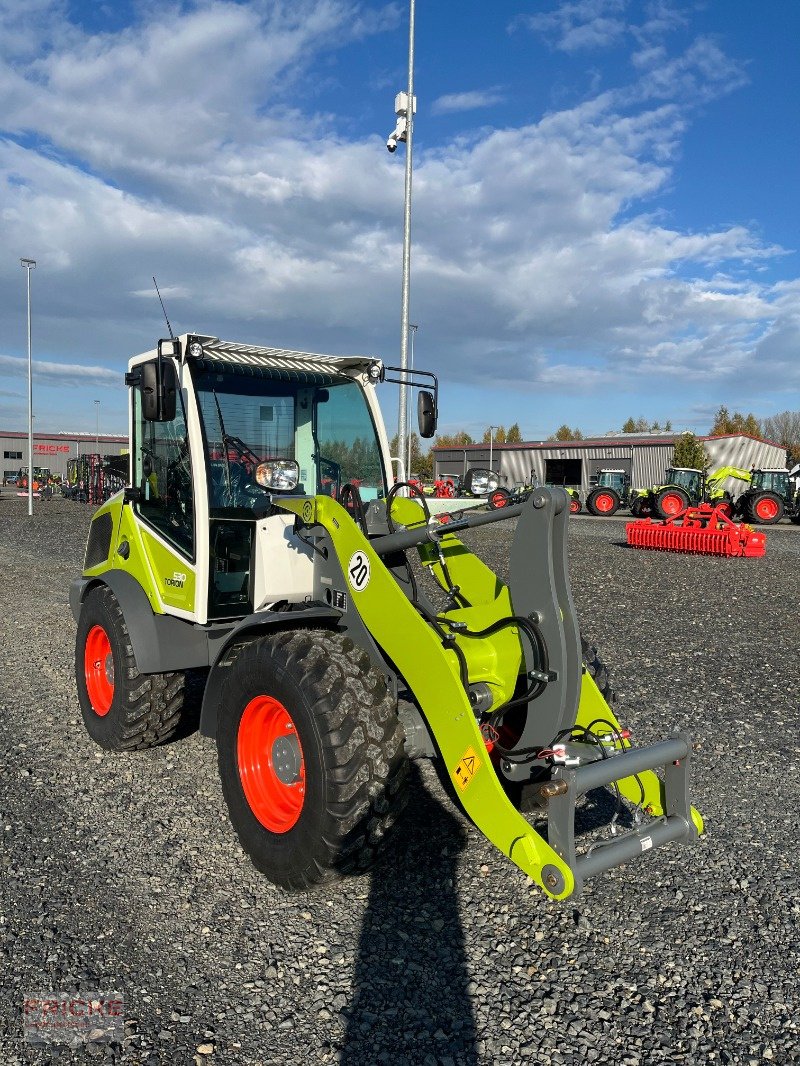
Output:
[[190, 370, 386, 514]]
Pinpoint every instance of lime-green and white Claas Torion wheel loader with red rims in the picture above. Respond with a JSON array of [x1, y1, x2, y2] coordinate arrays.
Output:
[[70, 335, 703, 900]]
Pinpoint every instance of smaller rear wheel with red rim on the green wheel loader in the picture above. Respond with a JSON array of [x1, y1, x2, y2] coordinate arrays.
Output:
[[75, 585, 186, 752]]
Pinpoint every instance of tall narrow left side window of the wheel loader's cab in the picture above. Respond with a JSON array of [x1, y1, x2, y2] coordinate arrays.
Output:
[[133, 375, 194, 556]]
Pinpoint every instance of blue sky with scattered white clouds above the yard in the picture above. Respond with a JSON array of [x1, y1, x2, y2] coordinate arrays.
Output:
[[0, 0, 800, 439]]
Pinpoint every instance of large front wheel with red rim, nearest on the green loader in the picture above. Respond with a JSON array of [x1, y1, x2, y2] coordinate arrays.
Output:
[[217, 629, 409, 890]]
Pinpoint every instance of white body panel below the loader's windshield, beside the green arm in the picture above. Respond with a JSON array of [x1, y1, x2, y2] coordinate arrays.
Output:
[[253, 515, 314, 611]]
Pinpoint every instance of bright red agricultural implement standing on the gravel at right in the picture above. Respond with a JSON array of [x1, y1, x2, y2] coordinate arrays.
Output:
[[625, 503, 767, 559]]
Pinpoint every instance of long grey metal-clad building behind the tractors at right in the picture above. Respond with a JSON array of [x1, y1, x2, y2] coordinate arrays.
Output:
[[433, 433, 786, 495]]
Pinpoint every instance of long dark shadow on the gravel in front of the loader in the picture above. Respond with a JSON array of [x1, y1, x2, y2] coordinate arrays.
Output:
[[338, 765, 478, 1066]]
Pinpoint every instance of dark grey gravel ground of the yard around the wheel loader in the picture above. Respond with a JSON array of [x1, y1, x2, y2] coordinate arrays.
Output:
[[0, 497, 800, 1066]]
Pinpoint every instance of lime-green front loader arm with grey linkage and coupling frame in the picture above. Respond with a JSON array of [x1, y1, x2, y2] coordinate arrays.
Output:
[[274, 489, 702, 899]]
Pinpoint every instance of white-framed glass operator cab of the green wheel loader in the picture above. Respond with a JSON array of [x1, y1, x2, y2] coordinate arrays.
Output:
[[126, 335, 436, 623]]
